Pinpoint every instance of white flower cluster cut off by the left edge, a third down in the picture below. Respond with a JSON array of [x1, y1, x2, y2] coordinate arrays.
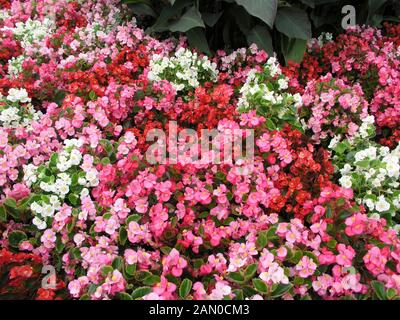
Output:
[[0, 88, 42, 130]]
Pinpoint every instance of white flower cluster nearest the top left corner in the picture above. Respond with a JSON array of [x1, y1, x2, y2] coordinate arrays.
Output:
[[3, 18, 54, 48]]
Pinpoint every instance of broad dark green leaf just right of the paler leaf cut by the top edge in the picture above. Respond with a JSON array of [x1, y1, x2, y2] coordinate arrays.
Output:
[[275, 7, 311, 40]]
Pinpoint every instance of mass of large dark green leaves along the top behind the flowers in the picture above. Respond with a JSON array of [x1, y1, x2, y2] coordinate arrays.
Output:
[[123, 0, 400, 62]]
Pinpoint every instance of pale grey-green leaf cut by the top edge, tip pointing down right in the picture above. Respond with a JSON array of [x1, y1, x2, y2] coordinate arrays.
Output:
[[236, 0, 278, 28]]
